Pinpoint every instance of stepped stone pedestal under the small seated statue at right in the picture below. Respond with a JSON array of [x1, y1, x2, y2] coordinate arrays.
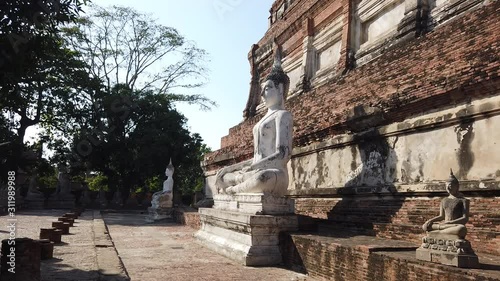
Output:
[[417, 235, 479, 268]]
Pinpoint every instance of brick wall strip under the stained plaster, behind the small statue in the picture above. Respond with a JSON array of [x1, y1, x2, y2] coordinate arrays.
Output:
[[295, 195, 500, 255]]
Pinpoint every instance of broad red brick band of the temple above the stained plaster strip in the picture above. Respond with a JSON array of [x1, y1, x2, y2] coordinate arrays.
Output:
[[206, 1, 500, 170]]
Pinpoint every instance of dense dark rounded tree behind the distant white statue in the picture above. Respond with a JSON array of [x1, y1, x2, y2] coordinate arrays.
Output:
[[70, 85, 206, 198]]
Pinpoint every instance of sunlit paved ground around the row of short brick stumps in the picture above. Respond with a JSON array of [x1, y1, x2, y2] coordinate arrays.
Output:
[[0, 210, 127, 281]]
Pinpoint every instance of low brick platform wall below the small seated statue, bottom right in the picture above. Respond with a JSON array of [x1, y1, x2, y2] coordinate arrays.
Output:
[[280, 233, 500, 281]]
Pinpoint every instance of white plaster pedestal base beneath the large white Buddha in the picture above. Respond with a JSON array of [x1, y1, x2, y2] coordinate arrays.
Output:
[[195, 208, 298, 266]]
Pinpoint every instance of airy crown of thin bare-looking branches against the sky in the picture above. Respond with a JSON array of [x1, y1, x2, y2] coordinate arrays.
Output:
[[64, 5, 215, 109]]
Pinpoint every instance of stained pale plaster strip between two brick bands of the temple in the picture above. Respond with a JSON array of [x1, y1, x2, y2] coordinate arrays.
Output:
[[289, 94, 500, 190]]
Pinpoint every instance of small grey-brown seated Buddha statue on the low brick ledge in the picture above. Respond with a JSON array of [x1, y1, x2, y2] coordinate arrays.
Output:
[[422, 168, 469, 239]]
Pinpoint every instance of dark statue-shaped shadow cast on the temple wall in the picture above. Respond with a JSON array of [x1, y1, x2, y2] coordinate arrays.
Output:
[[318, 106, 404, 237]]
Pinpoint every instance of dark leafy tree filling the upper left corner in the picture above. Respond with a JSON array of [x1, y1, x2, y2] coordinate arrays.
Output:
[[0, 0, 92, 176]]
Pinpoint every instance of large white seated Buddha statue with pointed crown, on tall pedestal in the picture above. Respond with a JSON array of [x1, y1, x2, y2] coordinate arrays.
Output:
[[215, 44, 293, 196]]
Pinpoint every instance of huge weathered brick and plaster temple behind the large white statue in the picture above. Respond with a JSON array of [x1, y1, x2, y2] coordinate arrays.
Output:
[[203, 0, 500, 280]]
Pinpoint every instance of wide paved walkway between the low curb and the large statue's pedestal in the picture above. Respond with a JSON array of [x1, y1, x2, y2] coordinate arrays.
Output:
[[104, 213, 314, 281]]
